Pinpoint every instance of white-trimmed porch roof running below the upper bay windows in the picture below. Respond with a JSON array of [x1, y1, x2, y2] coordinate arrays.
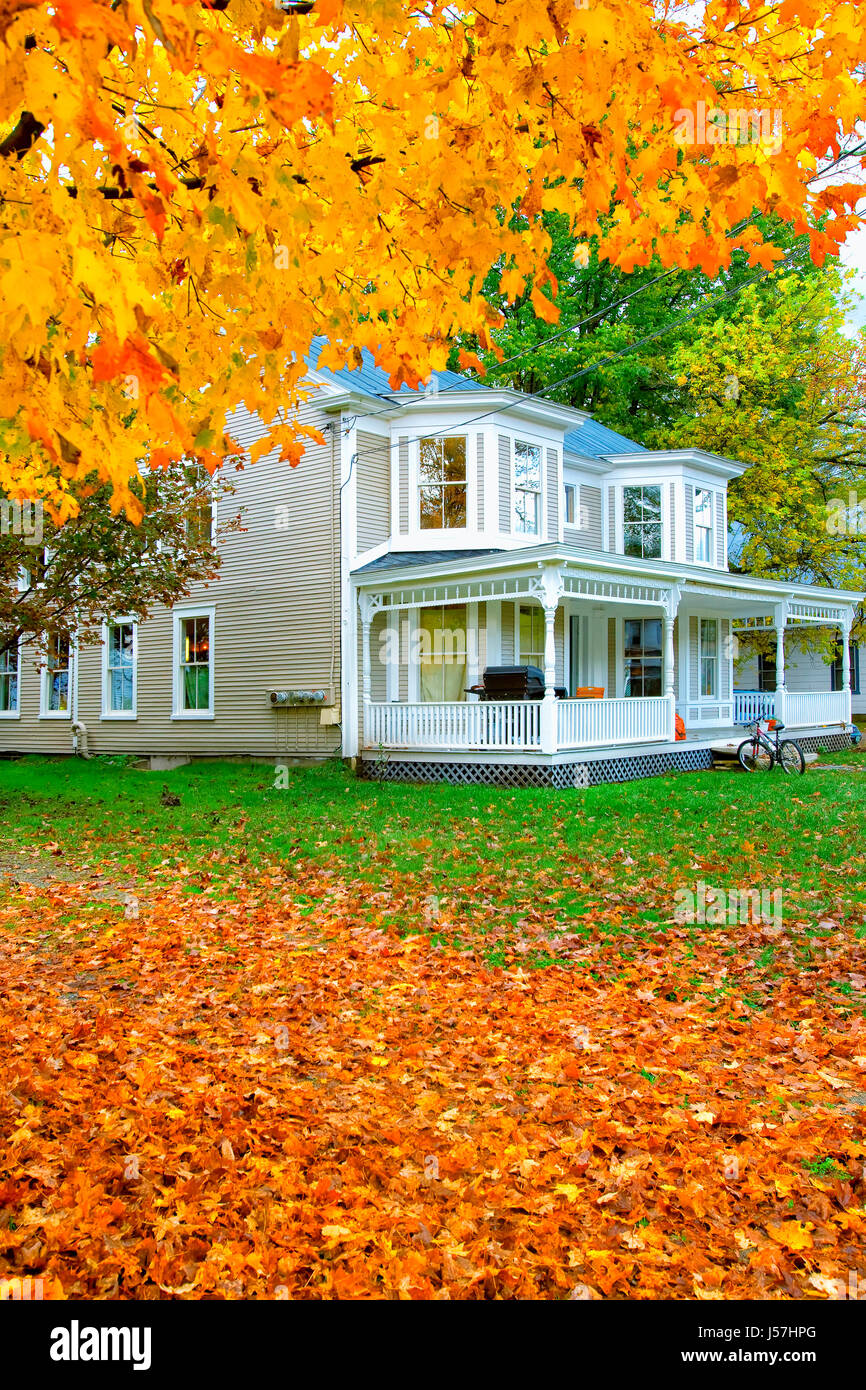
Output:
[[352, 542, 866, 624]]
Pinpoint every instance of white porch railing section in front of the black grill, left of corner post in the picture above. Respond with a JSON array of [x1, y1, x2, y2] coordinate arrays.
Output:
[[364, 701, 541, 751]]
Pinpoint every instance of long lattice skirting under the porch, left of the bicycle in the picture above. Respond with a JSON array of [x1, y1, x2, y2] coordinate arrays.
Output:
[[359, 748, 713, 788]]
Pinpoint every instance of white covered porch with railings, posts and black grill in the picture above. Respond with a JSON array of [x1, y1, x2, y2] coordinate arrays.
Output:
[[348, 546, 851, 762]]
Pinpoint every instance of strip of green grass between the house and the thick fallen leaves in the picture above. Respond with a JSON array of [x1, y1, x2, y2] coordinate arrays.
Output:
[[0, 753, 866, 963]]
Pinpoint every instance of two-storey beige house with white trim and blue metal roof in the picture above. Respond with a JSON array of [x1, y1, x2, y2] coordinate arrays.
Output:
[[0, 341, 863, 785]]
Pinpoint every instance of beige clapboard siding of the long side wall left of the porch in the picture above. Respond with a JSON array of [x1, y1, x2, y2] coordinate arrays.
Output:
[[0, 391, 341, 755]]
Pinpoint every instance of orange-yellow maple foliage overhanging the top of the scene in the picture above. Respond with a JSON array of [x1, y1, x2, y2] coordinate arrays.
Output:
[[0, 0, 863, 520]]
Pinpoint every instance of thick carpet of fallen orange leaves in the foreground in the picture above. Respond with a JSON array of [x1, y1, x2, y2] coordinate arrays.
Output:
[[0, 867, 866, 1300]]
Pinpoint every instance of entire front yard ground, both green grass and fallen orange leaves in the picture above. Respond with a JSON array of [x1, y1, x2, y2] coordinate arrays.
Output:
[[0, 763, 866, 1298]]
